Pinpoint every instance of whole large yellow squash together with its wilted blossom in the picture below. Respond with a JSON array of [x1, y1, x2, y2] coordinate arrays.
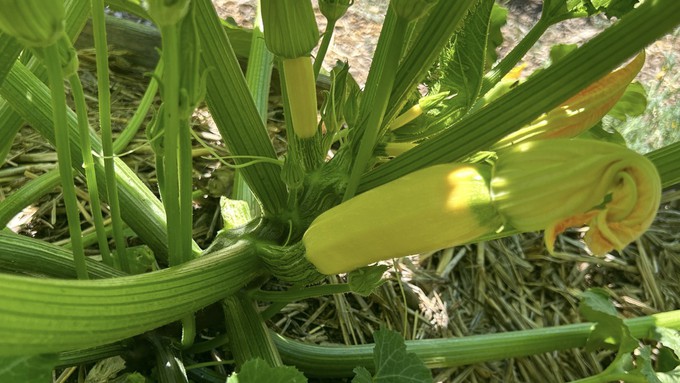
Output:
[[302, 139, 661, 274]]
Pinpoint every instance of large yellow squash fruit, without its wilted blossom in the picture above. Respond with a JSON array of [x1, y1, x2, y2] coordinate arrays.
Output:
[[303, 164, 502, 275]]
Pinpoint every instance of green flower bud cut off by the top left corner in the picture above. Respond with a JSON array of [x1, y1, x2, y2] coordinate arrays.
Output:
[[0, 0, 65, 48]]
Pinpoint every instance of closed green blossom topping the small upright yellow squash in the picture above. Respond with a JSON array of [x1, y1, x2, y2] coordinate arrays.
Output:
[[262, 0, 319, 59]]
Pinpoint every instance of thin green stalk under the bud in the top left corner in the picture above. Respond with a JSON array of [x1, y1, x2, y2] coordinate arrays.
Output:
[[45, 44, 88, 279]]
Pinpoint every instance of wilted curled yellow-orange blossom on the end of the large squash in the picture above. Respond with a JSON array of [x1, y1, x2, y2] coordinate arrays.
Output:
[[491, 139, 661, 255]]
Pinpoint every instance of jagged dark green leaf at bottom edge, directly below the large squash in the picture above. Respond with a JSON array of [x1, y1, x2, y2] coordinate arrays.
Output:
[[362, 328, 432, 383]]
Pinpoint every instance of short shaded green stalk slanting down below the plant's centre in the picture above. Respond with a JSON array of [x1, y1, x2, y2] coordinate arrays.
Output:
[[223, 294, 283, 367]]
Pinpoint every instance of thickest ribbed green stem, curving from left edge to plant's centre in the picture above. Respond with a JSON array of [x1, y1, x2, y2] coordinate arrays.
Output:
[[0, 241, 262, 356]]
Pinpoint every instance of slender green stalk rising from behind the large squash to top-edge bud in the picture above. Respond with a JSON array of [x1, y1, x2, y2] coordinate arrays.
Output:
[[343, 11, 408, 201]]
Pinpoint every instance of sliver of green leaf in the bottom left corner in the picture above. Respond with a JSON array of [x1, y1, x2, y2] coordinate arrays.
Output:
[[0, 354, 58, 383]]
